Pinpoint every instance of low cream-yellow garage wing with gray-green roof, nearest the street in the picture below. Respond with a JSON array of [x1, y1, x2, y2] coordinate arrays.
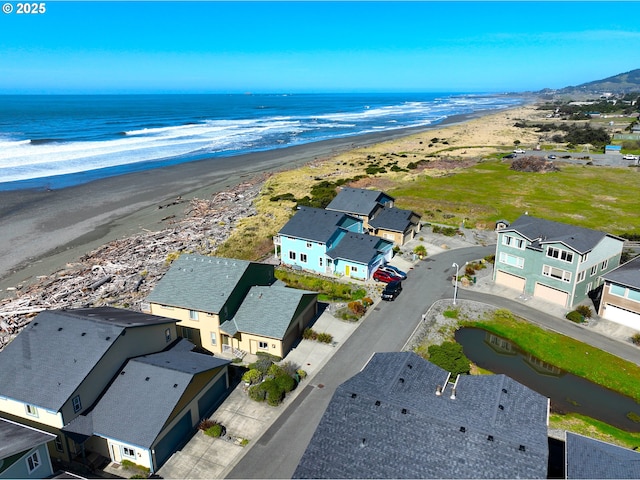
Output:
[[220, 285, 318, 358]]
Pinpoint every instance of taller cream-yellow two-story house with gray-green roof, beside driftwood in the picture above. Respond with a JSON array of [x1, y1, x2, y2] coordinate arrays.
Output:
[[142, 254, 275, 353]]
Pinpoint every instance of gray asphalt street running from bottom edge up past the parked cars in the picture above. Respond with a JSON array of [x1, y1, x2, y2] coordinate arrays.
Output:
[[226, 247, 495, 478]]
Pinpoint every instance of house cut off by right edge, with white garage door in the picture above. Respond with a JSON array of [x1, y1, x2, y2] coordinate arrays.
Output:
[[598, 256, 640, 331]]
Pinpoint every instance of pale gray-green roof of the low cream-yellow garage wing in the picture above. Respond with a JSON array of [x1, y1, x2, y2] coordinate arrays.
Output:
[[220, 286, 318, 340]]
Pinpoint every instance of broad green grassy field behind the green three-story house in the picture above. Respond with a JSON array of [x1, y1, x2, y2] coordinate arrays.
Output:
[[388, 160, 640, 234]]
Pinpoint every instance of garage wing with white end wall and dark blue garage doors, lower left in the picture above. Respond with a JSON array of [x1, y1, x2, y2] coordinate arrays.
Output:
[[63, 339, 230, 472]]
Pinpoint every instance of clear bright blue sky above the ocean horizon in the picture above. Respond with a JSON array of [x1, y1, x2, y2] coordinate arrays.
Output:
[[0, 0, 640, 93]]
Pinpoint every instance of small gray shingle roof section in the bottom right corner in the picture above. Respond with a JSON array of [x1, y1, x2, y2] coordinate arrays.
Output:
[[565, 432, 640, 479]]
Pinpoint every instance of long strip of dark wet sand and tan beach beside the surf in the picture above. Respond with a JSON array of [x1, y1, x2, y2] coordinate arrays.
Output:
[[0, 102, 535, 298]]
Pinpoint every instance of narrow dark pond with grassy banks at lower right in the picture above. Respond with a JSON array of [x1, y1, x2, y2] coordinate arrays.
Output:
[[455, 328, 640, 432]]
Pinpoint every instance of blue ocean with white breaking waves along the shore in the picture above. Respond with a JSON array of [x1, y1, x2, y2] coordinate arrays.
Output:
[[0, 93, 524, 191]]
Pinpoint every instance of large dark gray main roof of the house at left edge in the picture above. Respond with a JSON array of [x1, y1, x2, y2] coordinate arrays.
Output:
[[0, 307, 175, 411]]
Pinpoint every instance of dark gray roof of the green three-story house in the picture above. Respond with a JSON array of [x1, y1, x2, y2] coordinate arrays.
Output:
[[500, 215, 622, 254]]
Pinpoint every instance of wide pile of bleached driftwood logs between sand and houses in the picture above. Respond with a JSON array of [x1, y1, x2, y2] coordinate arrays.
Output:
[[0, 180, 261, 350]]
